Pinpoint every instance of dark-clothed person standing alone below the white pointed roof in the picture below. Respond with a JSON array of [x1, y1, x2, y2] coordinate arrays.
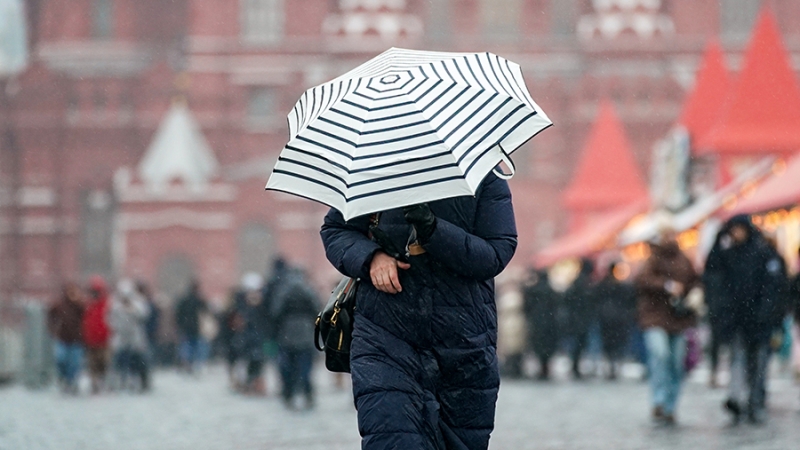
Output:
[[175, 280, 208, 373]]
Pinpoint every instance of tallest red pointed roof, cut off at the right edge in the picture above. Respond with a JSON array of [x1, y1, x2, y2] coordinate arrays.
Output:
[[697, 7, 800, 155]]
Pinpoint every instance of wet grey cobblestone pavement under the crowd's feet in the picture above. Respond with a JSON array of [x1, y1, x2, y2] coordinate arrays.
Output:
[[0, 360, 800, 450]]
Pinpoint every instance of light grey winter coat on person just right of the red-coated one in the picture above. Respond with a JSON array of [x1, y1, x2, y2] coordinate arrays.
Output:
[[109, 294, 150, 352]]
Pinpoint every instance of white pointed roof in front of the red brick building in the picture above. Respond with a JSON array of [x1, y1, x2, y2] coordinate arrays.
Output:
[[139, 102, 219, 190]]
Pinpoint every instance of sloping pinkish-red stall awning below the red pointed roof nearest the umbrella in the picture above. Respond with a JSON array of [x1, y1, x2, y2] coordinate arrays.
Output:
[[534, 200, 649, 267]]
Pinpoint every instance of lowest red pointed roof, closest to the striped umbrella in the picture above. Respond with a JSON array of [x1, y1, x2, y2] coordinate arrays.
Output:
[[562, 100, 648, 210]]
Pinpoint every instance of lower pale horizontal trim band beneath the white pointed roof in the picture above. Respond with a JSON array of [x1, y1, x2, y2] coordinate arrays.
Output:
[[118, 208, 234, 231]]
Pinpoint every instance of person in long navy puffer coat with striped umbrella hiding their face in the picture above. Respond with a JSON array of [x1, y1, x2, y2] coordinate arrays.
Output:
[[267, 48, 552, 450]]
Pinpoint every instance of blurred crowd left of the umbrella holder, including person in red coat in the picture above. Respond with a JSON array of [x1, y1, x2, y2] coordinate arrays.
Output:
[[48, 258, 320, 408]]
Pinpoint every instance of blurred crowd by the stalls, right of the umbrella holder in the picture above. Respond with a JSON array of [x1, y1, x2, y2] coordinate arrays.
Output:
[[500, 216, 800, 424]]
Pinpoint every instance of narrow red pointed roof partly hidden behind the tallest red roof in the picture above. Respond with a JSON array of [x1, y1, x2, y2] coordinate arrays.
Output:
[[678, 39, 731, 146]]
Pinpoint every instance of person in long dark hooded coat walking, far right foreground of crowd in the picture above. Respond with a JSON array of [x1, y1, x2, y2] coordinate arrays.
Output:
[[705, 215, 788, 423]]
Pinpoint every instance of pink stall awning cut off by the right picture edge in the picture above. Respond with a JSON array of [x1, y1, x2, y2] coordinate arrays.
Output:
[[731, 154, 800, 215]]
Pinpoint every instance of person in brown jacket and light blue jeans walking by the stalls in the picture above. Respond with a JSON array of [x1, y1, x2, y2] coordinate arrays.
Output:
[[635, 229, 700, 425]]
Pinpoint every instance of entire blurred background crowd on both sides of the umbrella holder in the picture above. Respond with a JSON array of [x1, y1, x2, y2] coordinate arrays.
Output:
[[43, 216, 800, 424]]
